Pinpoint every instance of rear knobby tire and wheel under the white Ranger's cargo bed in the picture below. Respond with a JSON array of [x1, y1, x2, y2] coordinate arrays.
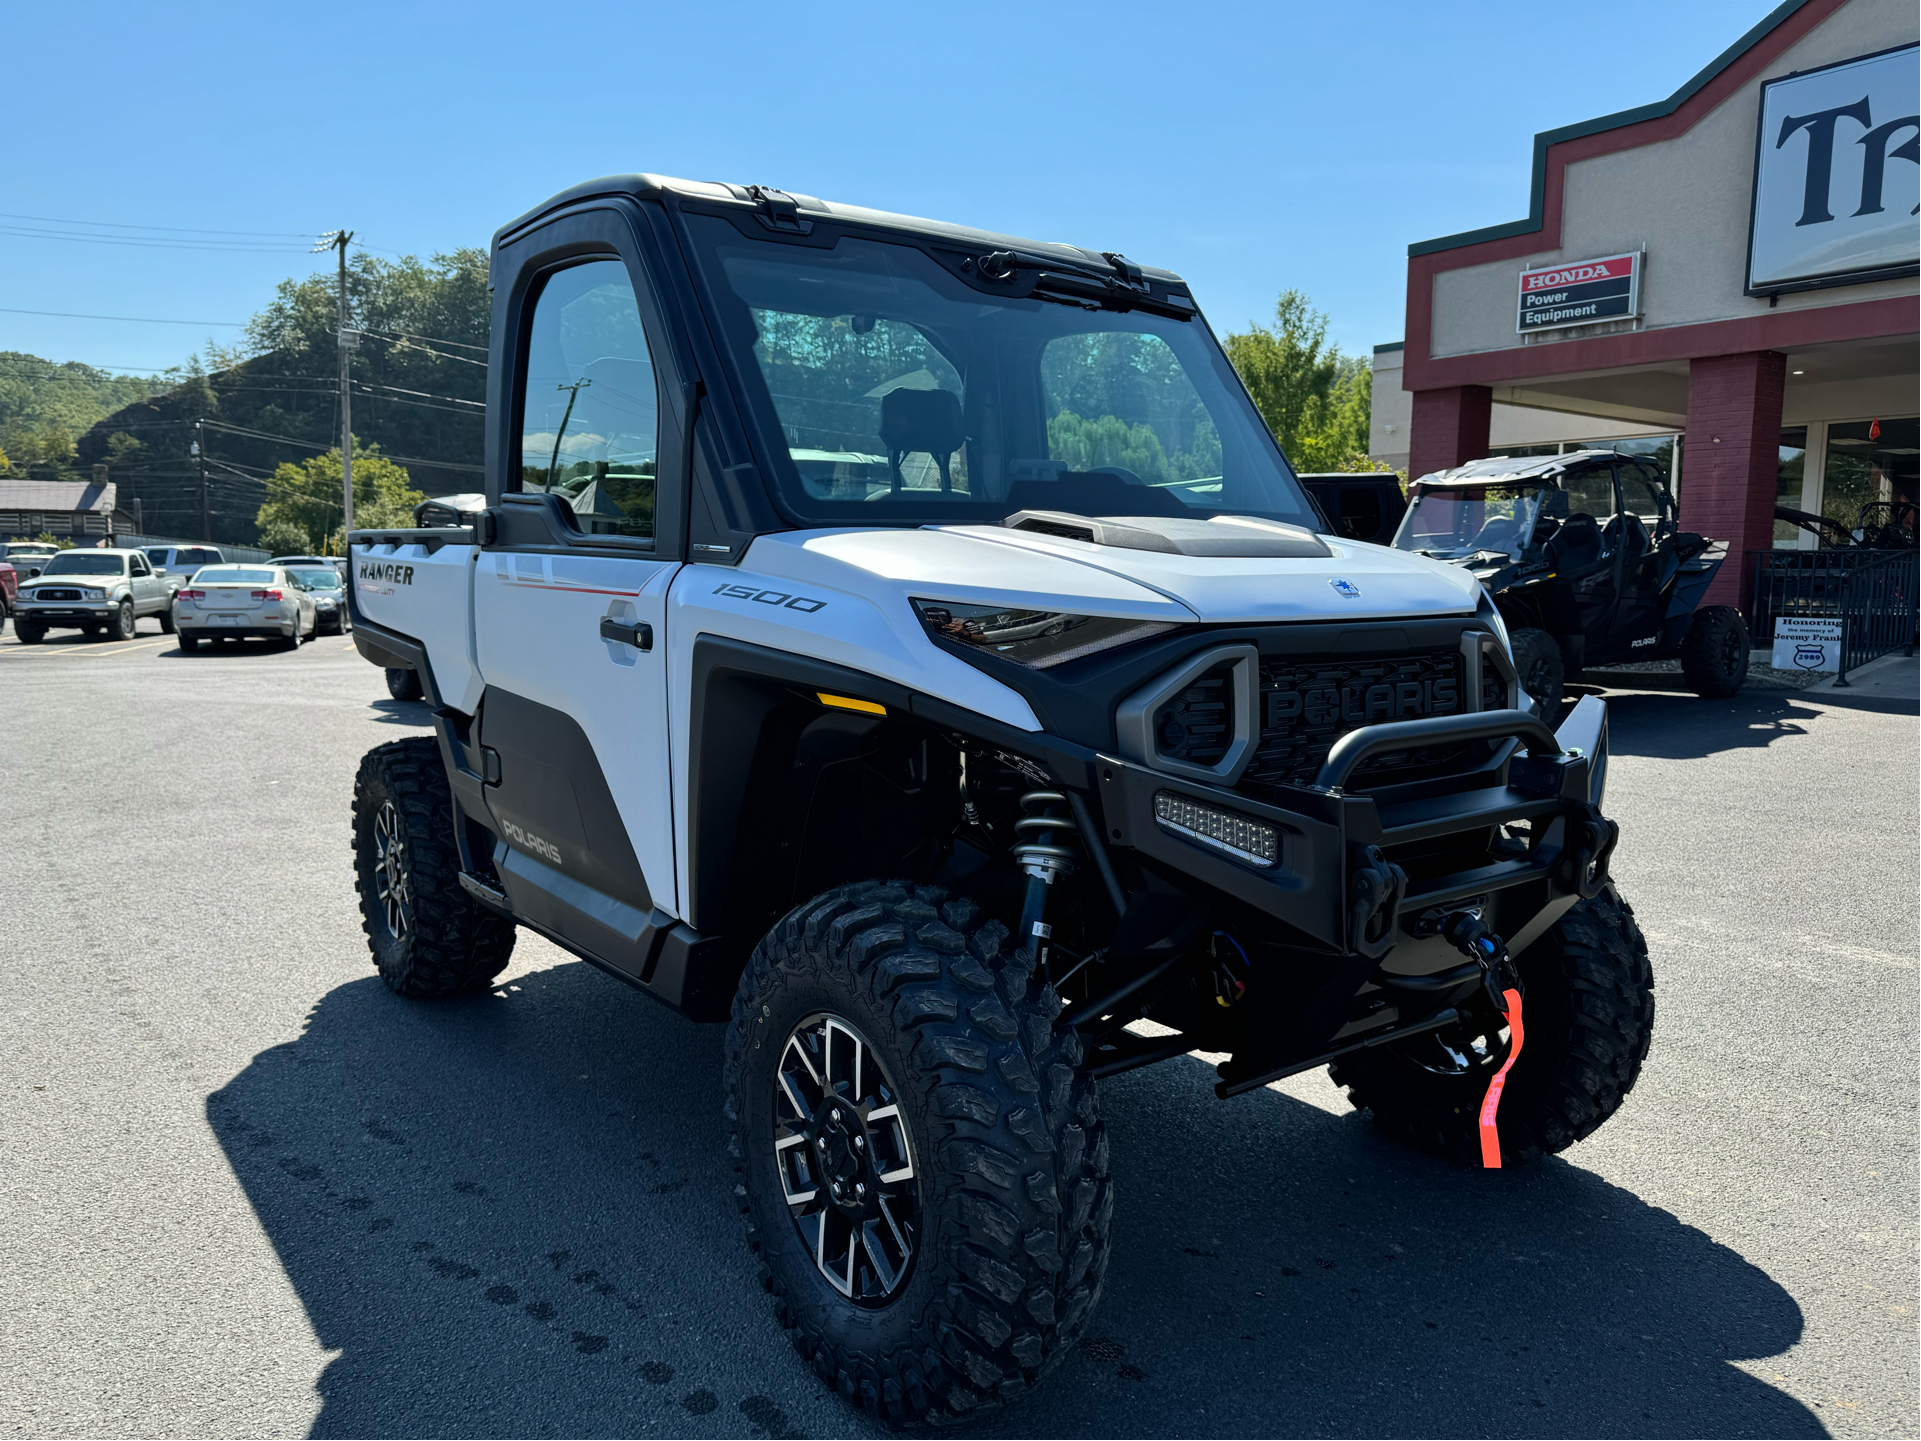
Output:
[[353, 736, 515, 995]]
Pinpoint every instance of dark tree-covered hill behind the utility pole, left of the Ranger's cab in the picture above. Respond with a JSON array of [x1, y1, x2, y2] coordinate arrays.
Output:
[[73, 250, 488, 544]]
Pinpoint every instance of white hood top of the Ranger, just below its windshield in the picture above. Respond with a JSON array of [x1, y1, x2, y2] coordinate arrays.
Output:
[[941, 526, 1481, 624]]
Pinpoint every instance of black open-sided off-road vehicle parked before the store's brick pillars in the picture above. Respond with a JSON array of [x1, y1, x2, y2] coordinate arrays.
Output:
[[1395, 450, 1750, 719]]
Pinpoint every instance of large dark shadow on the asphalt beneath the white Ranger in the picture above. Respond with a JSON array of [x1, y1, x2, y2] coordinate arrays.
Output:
[[207, 963, 1825, 1435]]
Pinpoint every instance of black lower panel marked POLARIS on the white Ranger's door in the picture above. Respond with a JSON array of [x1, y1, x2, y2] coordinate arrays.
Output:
[[476, 686, 653, 913]]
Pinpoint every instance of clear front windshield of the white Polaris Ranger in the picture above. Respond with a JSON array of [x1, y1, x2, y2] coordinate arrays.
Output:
[[688, 215, 1318, 528]]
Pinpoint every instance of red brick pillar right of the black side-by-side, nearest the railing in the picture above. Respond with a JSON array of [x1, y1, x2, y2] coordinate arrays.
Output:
[[1681, 350, 1788, 611]]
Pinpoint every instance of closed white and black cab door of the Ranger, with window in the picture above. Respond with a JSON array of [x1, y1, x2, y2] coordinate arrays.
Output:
[[473, 211, 682, 978]]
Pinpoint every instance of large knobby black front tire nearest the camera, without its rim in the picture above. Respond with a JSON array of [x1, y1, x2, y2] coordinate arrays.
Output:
[[726, 882, 1114, 1424]]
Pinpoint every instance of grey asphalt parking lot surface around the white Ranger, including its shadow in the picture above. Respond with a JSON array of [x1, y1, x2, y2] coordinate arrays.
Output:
[[0, 628, 1921, 1437]]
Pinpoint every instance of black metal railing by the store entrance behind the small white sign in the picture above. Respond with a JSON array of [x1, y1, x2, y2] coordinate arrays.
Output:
[[1748, 550, 1921, 684]]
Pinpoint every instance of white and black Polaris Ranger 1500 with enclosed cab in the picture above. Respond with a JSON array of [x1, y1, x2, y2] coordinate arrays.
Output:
[[352, 175, 1654, 1422]]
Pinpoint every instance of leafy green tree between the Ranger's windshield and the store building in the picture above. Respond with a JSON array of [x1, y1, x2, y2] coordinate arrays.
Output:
[[1226, 290, 1379, 471]]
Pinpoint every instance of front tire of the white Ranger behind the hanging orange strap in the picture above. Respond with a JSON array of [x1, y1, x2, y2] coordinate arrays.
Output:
[[1327, 884, 1654, 1162]]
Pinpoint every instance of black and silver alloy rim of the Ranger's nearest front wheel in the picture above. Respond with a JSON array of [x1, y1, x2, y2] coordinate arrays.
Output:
[[770, 1013, 920, 1307]]
